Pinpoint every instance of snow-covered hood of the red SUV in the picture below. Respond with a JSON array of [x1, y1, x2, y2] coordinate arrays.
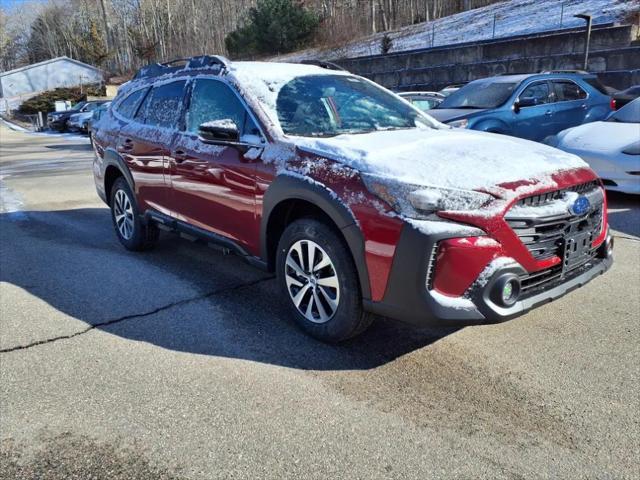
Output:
[[295, 128, 588, 194]]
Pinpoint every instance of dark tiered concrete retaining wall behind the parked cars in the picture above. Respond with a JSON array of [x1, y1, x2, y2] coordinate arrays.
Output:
[[336, 26, 640, 90]]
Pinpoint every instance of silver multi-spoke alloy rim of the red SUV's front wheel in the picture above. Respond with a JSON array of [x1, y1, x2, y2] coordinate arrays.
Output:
[[285, 240, 340, 323]]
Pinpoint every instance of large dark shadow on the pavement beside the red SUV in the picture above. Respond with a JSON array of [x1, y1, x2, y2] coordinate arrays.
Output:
[[0, 208, 455, 370]]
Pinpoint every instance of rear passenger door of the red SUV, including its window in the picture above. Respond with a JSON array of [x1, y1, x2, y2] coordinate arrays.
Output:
[[117, 80, 186, 215]]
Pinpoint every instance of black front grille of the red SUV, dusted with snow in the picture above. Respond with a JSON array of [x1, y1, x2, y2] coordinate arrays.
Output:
[[505, 182, 604, 260]]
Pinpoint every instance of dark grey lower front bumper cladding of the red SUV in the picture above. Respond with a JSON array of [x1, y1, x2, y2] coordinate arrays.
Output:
[[364, 224, 613, 327]]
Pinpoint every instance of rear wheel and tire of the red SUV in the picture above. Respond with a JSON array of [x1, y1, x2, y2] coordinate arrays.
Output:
[[110, 177, 160, 251]]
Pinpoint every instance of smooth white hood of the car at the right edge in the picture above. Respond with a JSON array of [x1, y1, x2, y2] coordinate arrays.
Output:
[[558, 122, 640, 153]]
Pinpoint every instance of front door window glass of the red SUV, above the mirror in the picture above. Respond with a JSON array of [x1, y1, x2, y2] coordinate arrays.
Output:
[[186, 79, 259, 135]]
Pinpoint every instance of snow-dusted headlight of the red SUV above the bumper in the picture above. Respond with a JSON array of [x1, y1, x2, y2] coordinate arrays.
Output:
[[361, 174, 493, 219]]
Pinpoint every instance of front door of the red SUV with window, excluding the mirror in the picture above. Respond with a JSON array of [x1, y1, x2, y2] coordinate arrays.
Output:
[[169, 78, 261, 251]]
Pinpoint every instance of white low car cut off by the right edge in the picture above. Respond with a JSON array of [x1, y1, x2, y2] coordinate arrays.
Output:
[[547, 98, 640, 194]]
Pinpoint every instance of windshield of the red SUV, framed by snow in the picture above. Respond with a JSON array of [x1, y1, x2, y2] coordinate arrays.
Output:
[[276, 75, 431, 137]]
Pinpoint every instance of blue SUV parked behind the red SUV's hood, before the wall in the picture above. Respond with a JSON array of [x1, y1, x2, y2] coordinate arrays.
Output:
[[429, 72, 611, 141]]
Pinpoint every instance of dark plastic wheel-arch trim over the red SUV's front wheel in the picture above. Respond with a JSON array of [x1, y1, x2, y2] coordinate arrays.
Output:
[[260, 174, 371, 299]]
